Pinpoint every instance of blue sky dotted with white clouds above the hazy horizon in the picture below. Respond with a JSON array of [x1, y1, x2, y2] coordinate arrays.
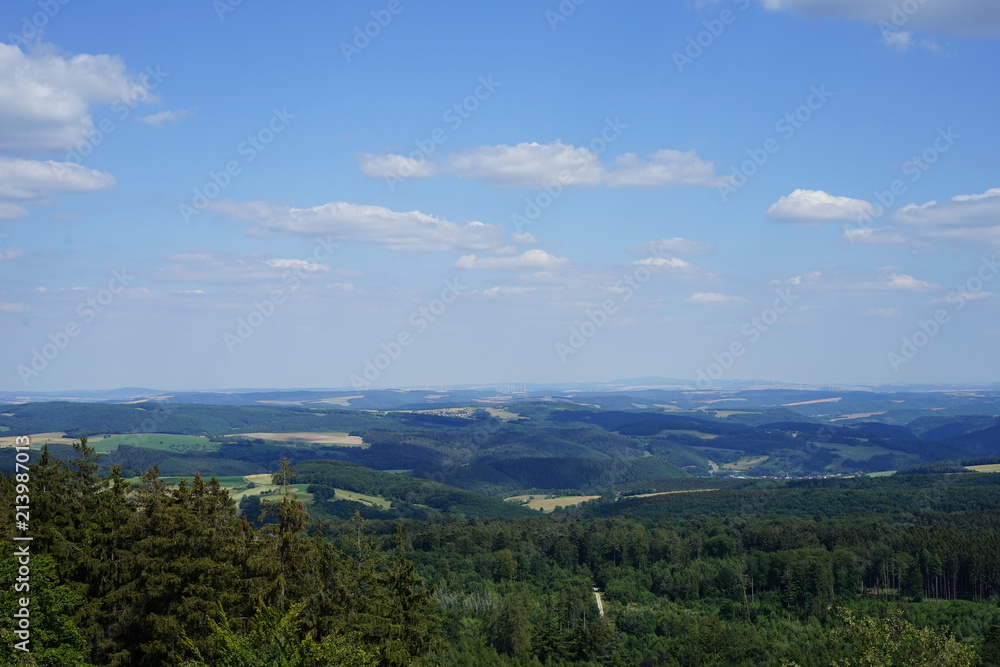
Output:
[[0, 0, 1000, 391]]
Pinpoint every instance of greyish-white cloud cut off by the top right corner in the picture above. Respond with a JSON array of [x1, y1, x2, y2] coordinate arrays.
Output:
[[759, 0, 1000, 36]]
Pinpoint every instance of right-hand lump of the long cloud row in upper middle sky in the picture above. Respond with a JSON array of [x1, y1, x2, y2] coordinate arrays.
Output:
[[604, 148, 729, 188]]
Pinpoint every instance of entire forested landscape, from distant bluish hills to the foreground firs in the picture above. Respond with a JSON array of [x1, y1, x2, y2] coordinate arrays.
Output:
[[0, 398, 1000, 667]]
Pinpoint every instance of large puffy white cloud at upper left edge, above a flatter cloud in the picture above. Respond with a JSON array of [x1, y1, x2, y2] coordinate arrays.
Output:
[[0, 43, 157, 153]]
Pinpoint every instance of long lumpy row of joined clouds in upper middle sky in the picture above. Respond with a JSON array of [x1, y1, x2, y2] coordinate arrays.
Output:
[[357, 141, 728, 190]]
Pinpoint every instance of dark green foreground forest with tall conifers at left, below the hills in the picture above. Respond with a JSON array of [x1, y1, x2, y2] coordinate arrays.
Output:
[[0, 443, 1000, 667]]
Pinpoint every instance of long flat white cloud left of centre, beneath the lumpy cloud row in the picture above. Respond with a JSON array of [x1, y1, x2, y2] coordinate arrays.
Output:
[[208, 200, 503, 252]]
